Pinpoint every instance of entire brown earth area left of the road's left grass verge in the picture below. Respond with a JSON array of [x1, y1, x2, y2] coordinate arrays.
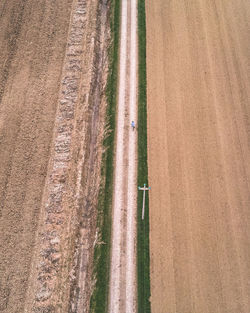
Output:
[[0, 0, 109, 313]]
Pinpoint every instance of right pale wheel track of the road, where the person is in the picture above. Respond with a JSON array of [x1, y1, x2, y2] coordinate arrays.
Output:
[[126, 0, 137, 313]]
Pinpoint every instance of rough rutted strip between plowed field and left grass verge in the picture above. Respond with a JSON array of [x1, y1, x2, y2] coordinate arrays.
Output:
[[25, 0, 108, 312]]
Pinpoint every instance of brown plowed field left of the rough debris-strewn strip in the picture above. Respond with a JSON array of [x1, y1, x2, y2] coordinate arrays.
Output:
[[0, 0, 72, 313]]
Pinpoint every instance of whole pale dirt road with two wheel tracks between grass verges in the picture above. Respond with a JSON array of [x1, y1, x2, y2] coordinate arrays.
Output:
[[109, 0, 137, 313]]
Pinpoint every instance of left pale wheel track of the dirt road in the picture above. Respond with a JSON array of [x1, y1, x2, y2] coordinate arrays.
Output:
[[109, 0, 127, 313]]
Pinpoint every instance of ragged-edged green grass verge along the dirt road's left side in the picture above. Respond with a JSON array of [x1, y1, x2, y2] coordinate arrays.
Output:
[[90, 0, 120, 313]]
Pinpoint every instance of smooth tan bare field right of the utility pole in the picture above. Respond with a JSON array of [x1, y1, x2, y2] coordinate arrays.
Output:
[[146, 0, 250, 313]]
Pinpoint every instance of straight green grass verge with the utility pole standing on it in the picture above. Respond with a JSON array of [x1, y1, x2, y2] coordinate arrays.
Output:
[[137, 0, 151, 313]]
